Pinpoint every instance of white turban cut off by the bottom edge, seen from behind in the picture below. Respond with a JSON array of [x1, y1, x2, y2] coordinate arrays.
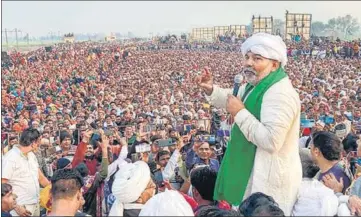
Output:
[[139, 190, 194, 216]]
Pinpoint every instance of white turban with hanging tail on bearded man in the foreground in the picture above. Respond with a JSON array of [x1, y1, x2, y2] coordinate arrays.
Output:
[[109, 161, 151, 216]]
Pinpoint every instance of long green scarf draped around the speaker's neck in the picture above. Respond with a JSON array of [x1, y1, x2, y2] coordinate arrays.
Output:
[[214, 67, 287, 206]]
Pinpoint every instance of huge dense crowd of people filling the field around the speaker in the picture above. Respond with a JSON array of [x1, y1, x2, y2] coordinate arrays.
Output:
[[1, 35, 361, 216]]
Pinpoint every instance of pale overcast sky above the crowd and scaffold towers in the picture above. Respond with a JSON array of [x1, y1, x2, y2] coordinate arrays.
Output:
[[2, 1, 361, 36]]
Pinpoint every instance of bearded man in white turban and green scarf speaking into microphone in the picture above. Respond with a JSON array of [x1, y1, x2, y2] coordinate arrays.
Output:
[[196, 33, 302, 216]]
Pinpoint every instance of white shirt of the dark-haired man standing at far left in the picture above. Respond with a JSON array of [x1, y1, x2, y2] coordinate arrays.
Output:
[[1, 146, 40, 205]]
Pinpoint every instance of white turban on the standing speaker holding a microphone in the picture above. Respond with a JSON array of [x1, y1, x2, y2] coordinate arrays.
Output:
[[241, 33, 287, 68]]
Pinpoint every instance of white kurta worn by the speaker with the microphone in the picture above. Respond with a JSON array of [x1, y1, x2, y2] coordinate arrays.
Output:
[[208, 77, 302, 216]]
